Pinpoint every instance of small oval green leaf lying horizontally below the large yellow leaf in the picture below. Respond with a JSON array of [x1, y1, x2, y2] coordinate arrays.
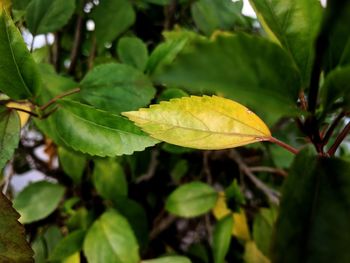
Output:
[[165, 182, 218, 217]]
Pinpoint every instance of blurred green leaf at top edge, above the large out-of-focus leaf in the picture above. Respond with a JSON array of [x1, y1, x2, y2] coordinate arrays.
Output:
[[191, 0, 247, 35]]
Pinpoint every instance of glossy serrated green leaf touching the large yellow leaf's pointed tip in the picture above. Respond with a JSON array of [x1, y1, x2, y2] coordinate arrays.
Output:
[[56, 100, 158, 156]]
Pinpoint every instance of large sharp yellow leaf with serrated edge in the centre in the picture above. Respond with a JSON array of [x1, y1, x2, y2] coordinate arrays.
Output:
[[123, 96, 271, 150]]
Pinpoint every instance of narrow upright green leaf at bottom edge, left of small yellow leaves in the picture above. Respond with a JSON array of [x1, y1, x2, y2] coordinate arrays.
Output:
[[213, 214, 233, 263]]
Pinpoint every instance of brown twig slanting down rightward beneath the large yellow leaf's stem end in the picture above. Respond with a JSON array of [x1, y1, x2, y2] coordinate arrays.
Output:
[[229, 150, 280, 205]]
